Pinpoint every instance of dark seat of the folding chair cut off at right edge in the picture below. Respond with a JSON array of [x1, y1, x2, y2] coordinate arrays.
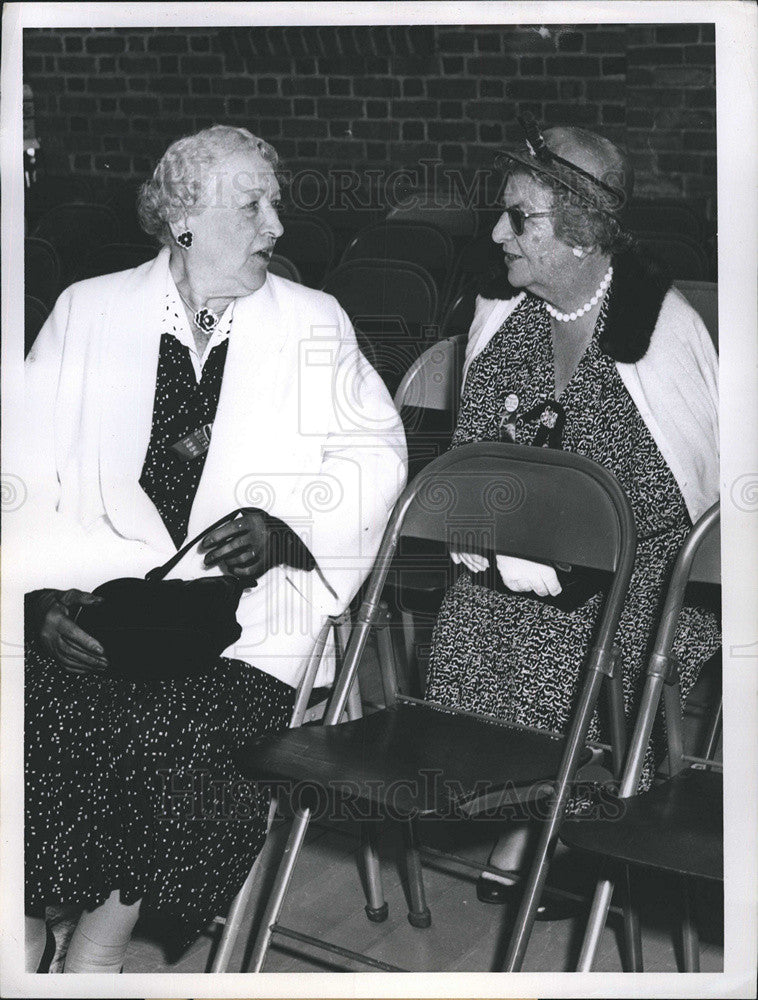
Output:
[[561, 767, 724, 881]]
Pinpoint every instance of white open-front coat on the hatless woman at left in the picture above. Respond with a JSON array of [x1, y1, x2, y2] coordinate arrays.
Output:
[[20, 249, 407, 685]]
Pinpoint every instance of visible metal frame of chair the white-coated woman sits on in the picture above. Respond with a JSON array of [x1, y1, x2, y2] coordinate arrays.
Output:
[[211, 610, 363, 972]]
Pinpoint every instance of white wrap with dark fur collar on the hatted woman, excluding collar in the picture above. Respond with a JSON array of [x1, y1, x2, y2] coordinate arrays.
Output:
[[463, 288, 719, 522]]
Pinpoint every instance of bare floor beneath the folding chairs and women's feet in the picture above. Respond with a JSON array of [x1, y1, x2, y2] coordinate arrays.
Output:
[[27, 636, 723, 973]]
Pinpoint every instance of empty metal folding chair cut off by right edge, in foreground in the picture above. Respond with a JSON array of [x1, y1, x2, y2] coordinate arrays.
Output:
[[561, 504, 723, 972]]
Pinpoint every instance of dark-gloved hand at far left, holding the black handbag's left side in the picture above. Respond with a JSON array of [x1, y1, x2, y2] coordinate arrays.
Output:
[[34, 590, 108, 674]]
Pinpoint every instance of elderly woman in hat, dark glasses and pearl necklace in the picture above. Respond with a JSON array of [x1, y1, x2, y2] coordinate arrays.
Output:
[[427, 119, 720, 918]]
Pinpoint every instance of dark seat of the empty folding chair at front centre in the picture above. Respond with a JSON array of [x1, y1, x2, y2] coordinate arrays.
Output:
[[243, 699, 566, 819]]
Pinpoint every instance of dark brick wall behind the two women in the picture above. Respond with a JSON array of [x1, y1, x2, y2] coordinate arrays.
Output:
[[24, 24, 716, 219]]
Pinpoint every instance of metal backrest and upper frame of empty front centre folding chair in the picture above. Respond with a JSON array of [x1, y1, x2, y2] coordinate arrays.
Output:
[[326, 442, 636, 724]]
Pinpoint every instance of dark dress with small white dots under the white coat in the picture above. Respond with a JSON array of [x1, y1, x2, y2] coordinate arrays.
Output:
[[25, 294, 295, 940]]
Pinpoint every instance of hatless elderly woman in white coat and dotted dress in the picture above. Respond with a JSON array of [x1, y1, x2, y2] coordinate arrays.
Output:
[[19, 126, 405, 972]]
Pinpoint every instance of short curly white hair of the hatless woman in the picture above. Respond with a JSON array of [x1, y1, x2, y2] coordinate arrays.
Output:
[[137, 125, 279, 246]]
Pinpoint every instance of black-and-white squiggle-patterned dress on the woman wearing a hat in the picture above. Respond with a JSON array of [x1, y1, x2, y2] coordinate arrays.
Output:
[[427, 289, 720, 785]]
